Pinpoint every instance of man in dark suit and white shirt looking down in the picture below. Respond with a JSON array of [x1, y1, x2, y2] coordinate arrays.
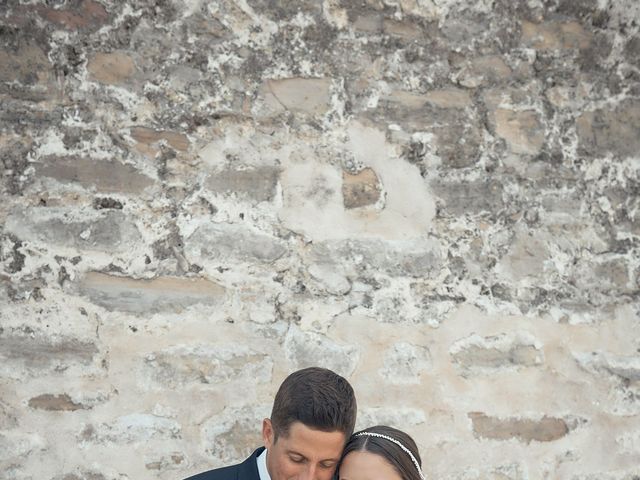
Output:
[[187, 367, 357, 480]]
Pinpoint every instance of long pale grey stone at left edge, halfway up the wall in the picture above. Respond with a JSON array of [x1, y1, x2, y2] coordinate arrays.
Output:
[[5, 208, 141, 252]]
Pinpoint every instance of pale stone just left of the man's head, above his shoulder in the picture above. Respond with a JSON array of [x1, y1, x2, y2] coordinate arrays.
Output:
[[202, 405, 271, 466]]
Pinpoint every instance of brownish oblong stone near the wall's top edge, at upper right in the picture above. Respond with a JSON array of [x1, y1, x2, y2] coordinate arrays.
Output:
[[522, 21, 592, 50]]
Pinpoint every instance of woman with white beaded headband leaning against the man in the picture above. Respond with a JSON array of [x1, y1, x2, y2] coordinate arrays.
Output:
[[338, 425, 425, 480]]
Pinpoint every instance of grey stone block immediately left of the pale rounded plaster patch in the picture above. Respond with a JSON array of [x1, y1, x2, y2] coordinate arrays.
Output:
[[206, 166, 280, 202]]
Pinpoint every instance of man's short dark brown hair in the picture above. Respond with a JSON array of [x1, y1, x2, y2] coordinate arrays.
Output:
[[271, 367, 357, 440]]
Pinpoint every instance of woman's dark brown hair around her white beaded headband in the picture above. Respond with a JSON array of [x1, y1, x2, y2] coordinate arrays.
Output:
[[336, 425, 422, 480]]
